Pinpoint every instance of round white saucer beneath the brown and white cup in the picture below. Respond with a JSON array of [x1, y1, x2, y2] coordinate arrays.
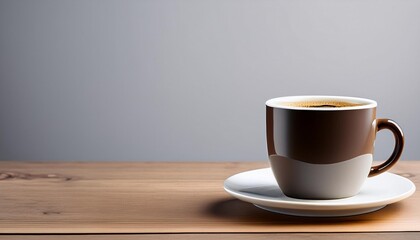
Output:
[[224, 168, 416, 217]]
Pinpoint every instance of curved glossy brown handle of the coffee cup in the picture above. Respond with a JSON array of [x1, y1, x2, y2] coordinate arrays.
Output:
[[369, 118, 404, 177]]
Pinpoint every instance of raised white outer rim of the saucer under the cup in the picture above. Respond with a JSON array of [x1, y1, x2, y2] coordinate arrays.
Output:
[[224, 168, 416, 210]]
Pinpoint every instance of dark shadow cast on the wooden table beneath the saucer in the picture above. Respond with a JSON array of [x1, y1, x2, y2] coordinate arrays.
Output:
[[205, 199, 401, 225]]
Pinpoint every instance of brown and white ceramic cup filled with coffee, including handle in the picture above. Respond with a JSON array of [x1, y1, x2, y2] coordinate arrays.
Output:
[[266, 96, 404, 199]]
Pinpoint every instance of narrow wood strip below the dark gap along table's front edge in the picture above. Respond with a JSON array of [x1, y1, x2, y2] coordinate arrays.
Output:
[[0, 232, 420, 240]]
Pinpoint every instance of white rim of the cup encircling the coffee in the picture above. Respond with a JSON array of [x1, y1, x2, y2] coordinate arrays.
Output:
[[265, 95, 378, 111]]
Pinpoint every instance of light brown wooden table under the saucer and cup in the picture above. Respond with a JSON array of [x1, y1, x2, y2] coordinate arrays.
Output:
[[0, 161, 420, 240]]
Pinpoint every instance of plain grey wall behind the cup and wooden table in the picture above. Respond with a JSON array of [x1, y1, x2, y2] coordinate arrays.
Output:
[[0, 0, 420, 161]]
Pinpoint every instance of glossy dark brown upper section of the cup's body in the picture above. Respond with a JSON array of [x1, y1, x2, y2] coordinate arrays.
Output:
[[266, 106, 376, 164]]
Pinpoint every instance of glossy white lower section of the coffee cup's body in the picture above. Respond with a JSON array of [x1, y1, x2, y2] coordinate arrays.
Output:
[[270, 154, 373, 199]]
